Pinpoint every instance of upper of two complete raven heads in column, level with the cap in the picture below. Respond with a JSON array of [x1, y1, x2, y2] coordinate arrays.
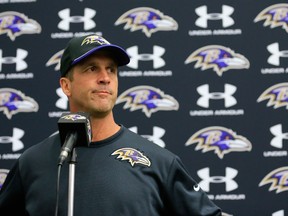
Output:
[[185, 45, 250, 76]]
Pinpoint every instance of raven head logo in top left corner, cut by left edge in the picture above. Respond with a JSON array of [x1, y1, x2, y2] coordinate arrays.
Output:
[[0, 11, 41, 41]]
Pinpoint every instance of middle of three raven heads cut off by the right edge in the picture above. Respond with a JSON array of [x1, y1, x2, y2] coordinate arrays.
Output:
[[257, 83, 288, 109]]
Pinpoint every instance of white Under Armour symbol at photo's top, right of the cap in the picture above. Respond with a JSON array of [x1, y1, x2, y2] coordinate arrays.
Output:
[[195, 5, 234, 28]]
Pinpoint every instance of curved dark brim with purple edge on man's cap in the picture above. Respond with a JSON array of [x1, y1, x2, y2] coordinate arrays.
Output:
[[71, 44, 130, 66]]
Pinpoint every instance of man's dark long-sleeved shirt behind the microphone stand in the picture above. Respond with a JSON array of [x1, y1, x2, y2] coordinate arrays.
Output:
[[0, 127, 221, 216]]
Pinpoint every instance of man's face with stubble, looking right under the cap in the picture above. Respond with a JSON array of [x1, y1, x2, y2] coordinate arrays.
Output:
[[62, 52, 118, 117]]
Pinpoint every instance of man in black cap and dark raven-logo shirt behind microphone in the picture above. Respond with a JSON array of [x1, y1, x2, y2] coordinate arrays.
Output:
[[0, 35, 221, 216]]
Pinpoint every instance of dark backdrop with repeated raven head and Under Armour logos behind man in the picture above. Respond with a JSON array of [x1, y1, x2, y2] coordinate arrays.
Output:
[[0, 0, 288, 216]]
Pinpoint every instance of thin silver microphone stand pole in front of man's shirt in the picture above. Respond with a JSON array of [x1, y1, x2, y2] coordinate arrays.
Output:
[[68, 148, 77, 216]]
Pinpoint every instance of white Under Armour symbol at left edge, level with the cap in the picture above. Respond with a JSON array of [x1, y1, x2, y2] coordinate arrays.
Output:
[[0, 49, 28, 72]]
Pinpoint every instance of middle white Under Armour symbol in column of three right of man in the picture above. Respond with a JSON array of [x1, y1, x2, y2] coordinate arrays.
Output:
[[197, 84, 237, 108]]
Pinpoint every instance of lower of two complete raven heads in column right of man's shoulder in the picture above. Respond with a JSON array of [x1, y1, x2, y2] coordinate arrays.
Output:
[[185, 126, 252, 159]]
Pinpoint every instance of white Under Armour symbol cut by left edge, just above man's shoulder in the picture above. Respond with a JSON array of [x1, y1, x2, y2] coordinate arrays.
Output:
[[0, 128, 25, 152]]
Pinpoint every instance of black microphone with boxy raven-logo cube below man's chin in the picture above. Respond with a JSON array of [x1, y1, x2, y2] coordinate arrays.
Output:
[[58, 112, 92, 165]]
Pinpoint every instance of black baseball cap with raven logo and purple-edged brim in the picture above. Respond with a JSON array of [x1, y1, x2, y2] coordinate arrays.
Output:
[[60, 34, 130, 77]]
